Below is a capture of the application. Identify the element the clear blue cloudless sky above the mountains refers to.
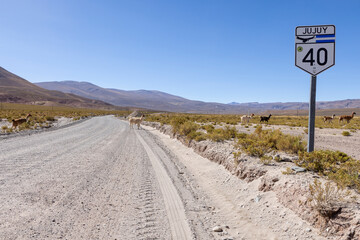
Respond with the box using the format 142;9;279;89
0;0;360;103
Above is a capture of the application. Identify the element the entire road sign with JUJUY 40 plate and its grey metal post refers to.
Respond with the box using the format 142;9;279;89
295;25;335;152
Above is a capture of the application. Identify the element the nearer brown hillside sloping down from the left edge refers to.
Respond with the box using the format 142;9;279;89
0;67;114;109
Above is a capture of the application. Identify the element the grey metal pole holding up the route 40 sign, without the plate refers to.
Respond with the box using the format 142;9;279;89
308;76;316;152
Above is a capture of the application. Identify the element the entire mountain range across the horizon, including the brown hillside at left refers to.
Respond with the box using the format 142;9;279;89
0;67;360;114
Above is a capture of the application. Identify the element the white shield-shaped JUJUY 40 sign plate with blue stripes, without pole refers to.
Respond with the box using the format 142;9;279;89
295;25;335;76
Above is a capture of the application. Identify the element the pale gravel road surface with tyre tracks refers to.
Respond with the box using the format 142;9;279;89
0;116;200;240
